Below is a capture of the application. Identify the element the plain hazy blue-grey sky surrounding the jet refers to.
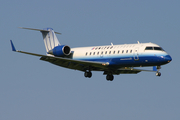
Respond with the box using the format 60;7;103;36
0;0;180;120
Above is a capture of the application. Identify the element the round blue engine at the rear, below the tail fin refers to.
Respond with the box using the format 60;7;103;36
48;45;71;57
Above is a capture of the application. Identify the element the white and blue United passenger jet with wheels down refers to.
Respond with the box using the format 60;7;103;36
10;27;172;81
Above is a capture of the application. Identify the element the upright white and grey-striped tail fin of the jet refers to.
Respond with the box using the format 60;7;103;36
41;28;60;52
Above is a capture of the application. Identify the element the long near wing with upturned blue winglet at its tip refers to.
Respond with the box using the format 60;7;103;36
10;40;108;71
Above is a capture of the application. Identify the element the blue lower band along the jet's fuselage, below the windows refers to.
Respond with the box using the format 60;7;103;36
74;53;170;67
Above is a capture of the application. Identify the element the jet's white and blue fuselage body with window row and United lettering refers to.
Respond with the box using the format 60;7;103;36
72;43;170;66
